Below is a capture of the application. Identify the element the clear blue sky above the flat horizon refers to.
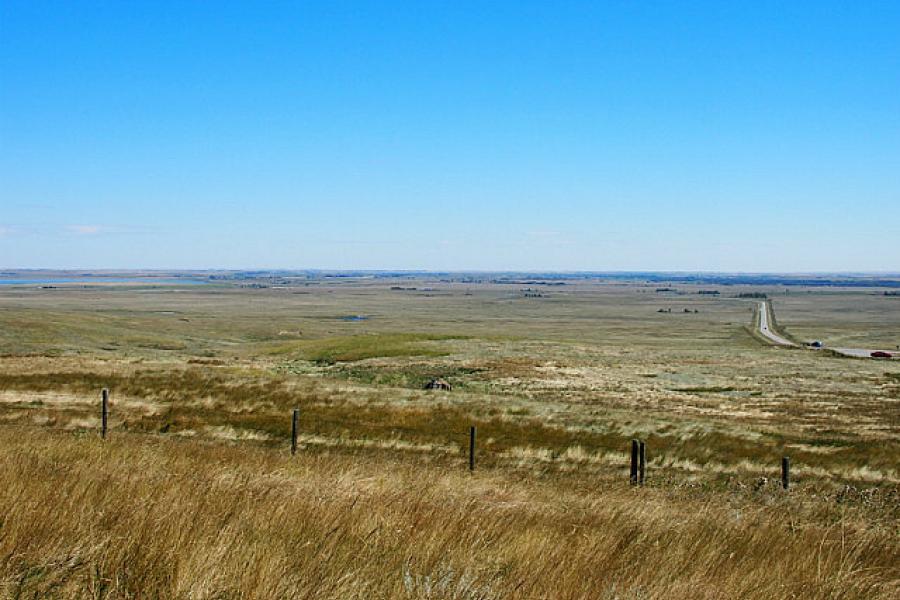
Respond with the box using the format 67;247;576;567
0;0;900;271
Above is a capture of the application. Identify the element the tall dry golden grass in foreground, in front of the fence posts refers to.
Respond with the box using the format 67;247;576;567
0;428;900;599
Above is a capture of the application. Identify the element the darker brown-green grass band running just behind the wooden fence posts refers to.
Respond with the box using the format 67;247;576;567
0;366;900;483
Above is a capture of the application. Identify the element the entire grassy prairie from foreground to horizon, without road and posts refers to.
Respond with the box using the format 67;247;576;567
0;279;900;598
